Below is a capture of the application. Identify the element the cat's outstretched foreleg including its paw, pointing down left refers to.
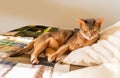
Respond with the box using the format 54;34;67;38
48;45;69;62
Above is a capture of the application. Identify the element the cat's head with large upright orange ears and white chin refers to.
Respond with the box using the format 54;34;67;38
78;18;103;40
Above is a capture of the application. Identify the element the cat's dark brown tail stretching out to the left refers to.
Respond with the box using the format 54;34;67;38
10;40;34;56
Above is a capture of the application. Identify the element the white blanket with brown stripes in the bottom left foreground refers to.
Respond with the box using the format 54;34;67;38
0;59;70;78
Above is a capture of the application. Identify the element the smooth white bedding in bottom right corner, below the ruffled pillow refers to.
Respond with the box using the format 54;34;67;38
58;63;120;78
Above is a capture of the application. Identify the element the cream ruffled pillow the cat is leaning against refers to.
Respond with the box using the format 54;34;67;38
63;23;120;66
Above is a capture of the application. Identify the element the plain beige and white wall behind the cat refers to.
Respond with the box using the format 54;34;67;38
0;0;120;32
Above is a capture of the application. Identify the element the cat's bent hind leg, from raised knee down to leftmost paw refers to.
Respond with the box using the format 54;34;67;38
31;37;59;64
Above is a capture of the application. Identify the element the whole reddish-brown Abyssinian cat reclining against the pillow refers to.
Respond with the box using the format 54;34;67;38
13;18;103;64
